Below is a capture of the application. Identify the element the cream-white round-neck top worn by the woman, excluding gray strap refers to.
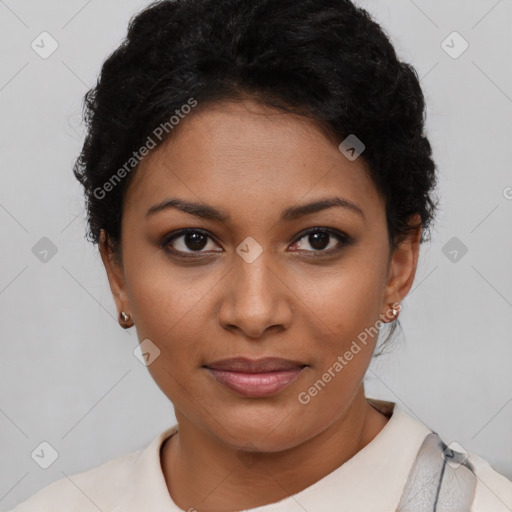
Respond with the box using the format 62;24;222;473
11;398;512;512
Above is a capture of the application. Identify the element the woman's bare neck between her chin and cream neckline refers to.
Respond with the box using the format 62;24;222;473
161;385;388;512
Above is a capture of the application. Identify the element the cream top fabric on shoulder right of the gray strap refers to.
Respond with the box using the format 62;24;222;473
468;453;512;512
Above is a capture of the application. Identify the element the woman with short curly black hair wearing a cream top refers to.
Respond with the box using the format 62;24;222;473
9;0;512;512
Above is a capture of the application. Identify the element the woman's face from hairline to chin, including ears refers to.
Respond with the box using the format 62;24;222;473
102;100;416;451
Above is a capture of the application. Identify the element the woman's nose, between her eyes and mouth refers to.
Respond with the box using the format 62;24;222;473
218;251;294;340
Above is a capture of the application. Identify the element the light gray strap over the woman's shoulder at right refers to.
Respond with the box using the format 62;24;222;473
396;432;476;512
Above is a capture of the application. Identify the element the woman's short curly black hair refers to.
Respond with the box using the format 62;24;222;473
73;0;437;354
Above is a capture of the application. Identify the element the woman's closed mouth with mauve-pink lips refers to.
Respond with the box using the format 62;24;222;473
204;357;308;398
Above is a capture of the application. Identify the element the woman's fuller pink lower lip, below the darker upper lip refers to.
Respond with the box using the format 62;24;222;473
207;368;304;398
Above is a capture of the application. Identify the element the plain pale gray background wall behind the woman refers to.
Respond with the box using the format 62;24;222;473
0;0;512;511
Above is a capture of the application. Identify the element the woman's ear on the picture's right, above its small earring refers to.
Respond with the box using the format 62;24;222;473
381;214;422;315
